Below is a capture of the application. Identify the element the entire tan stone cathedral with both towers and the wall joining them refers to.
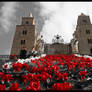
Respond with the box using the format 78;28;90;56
11;13;92;55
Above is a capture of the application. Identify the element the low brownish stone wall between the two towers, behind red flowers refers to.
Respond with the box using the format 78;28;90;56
44;43;71;54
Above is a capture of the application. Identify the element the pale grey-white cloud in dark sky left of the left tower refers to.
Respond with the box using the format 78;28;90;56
0;2;19;32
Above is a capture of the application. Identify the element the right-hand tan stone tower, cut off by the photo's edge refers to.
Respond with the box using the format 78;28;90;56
71;13;92;55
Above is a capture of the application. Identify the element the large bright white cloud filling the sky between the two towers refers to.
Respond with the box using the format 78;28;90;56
40;2;92;43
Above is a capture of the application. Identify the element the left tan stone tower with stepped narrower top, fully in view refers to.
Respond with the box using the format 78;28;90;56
11;13;37;55
